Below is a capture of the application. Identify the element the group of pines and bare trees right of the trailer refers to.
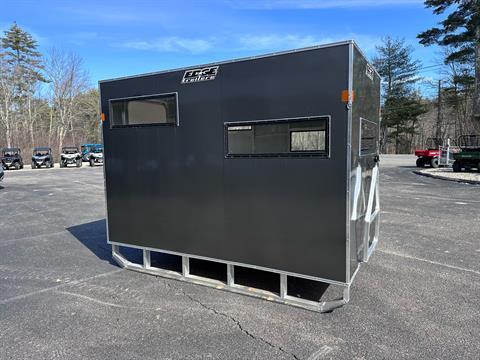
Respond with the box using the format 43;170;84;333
373;0;480;153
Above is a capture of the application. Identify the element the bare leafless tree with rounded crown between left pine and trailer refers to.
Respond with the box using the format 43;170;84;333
45;49;89;151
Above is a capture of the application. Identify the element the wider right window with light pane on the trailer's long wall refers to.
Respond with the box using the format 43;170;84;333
225;116;329;157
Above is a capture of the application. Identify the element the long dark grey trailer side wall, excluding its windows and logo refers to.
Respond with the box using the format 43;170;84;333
100;44;349;282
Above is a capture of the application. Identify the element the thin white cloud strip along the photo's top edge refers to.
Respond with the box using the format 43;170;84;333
228;0;423;10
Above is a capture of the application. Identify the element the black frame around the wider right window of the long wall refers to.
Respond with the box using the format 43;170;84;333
223;115;332;159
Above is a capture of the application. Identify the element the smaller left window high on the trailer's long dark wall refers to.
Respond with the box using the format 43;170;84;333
111;94;178;127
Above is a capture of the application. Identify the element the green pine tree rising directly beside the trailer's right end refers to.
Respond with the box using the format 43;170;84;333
373;37;426;153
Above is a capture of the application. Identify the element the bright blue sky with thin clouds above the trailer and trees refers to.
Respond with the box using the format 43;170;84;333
0;0;440;94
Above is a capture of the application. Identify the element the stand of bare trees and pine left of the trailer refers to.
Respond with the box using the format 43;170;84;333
0;23;101;158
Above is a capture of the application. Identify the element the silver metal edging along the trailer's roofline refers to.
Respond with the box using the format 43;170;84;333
98;40;380;84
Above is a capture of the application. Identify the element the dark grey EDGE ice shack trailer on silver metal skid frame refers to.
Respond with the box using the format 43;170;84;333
99;41;380;311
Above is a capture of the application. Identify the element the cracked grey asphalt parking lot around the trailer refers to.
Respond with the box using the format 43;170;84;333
0;156;480;360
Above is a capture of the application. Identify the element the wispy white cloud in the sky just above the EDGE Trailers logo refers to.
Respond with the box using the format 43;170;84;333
120;36;213;53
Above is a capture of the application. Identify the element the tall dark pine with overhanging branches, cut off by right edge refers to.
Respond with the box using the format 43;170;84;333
418;0;480;122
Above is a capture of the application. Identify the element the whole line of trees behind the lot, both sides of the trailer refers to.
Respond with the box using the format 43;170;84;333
0;0;480;153
